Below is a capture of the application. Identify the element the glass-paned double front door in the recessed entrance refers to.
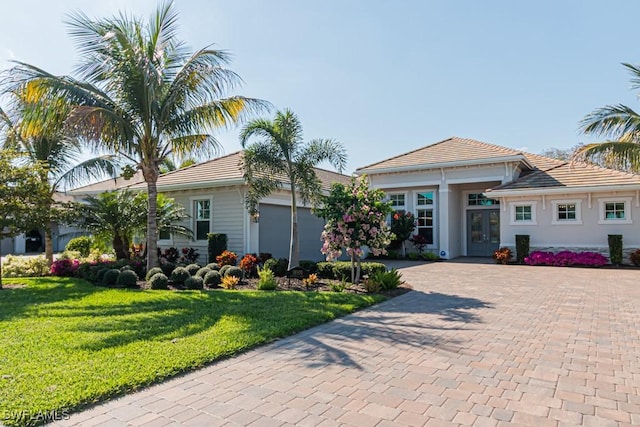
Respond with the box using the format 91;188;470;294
467;209;500;256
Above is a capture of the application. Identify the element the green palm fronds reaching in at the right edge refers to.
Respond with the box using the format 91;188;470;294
574;64;640;173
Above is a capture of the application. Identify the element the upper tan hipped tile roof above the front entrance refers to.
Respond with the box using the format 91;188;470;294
356;136;562;173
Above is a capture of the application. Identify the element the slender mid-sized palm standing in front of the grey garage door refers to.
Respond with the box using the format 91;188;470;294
240;110;347;269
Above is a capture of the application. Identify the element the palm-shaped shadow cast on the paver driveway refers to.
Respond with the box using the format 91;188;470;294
280;291;493;369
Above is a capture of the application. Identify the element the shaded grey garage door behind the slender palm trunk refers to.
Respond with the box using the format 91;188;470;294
259;203;324;261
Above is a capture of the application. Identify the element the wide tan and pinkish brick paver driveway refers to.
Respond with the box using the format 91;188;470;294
60;262;640;426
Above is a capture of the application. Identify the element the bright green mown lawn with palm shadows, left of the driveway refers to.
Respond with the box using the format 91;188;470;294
0;277;383;425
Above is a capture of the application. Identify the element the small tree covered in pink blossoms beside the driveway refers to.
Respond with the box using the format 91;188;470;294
315;176;395;283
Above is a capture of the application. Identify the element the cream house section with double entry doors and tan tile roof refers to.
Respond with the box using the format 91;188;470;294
356;137;640;259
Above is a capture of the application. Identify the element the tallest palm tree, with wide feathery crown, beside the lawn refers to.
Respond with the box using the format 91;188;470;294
5;3;267;268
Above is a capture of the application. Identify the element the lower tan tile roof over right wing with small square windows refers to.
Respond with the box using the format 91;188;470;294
489;162;640;192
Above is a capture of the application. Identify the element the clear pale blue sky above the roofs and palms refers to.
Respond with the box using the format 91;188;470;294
0;0;640;172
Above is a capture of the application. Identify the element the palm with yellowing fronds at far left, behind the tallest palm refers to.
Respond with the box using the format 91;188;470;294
0;90;116;263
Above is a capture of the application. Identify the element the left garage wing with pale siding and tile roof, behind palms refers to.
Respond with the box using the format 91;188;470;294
72;151;350;262
